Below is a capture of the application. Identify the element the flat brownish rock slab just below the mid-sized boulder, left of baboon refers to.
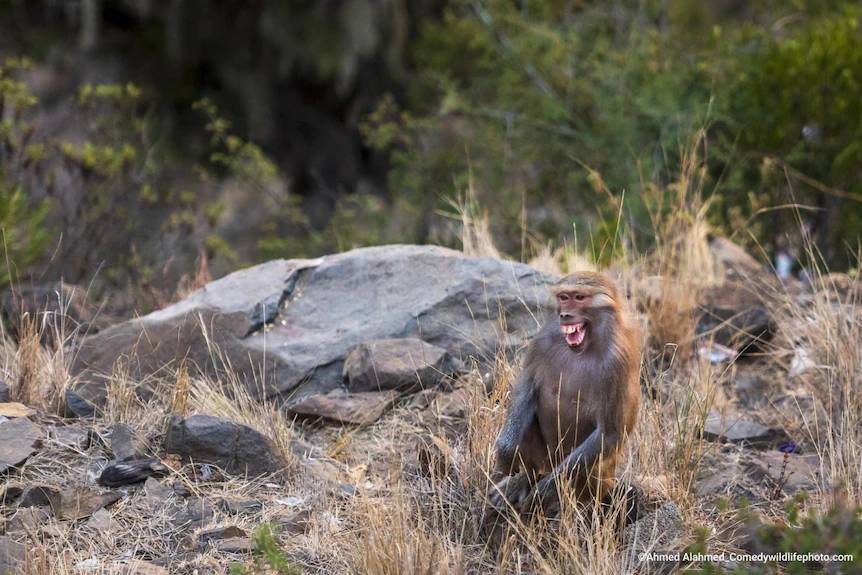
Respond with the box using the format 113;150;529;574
288;390;400;425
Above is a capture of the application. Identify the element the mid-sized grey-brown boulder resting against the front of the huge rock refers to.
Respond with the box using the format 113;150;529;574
344;337;455;392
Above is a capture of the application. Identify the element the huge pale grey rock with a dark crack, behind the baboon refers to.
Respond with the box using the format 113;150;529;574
72;245;554;403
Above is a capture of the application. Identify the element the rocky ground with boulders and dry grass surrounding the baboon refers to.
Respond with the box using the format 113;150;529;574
0;244;862;574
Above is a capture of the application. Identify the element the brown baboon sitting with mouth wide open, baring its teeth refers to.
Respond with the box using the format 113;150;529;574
490;272;640;511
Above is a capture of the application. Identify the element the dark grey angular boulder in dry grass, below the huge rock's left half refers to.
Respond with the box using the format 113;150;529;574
165;415;285;477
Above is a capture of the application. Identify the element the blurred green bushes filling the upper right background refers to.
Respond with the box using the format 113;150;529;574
364;0;862;266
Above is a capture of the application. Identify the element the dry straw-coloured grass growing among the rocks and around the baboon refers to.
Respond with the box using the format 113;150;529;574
0;137;862;575
